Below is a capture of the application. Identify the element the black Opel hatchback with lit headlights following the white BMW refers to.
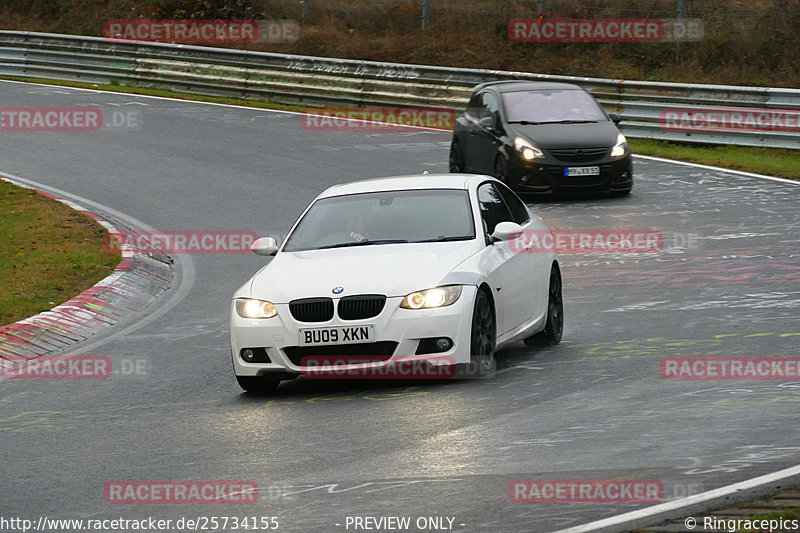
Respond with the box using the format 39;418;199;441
450;81;633;194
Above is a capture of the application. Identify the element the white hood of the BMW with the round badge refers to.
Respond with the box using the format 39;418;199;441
243;239;478;303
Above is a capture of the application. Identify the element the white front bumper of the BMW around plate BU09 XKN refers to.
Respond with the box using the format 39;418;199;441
230;285;477;378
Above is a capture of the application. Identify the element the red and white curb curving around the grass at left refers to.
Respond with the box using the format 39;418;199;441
0;175;173;365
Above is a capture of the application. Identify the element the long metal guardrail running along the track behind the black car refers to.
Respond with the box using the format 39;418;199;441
0;31;800;149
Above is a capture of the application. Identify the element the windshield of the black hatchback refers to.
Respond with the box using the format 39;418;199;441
502;90;607;124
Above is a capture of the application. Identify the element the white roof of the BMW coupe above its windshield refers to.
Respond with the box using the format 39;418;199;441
318;174;494;198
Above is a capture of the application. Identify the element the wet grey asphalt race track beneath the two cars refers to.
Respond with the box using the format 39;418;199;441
0;82;800;532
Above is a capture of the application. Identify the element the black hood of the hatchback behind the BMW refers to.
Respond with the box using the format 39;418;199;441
510;121;619;149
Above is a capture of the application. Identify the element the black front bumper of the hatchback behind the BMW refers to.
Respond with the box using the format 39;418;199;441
509;155;633;194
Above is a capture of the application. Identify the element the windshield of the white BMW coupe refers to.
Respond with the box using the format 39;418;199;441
283;189;475;252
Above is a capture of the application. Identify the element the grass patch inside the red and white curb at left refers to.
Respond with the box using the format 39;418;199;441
0;180;120;325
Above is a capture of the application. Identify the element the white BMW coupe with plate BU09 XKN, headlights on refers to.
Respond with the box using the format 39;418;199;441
230;174;564;392
